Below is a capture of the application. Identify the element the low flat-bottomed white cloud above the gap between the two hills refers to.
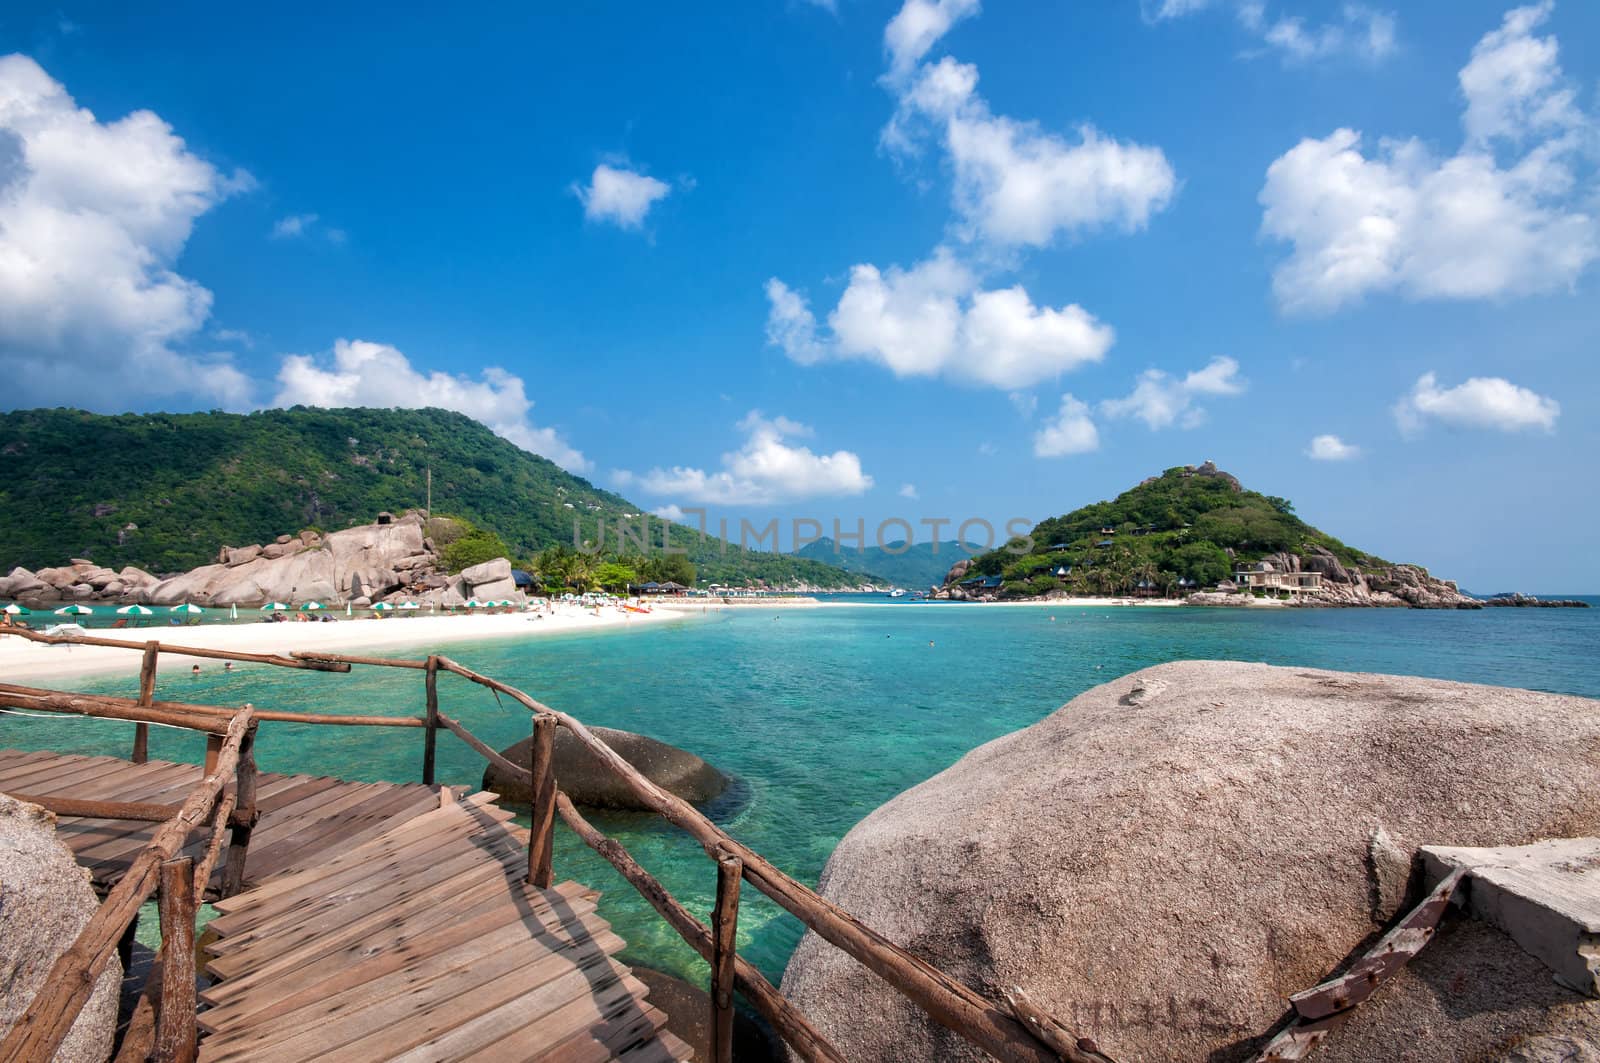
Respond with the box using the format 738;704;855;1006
624;410;872;506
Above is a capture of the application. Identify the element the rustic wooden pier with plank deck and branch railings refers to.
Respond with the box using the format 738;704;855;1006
0;631;1107;1063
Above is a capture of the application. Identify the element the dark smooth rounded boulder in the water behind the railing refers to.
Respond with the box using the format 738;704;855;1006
483;727;728;808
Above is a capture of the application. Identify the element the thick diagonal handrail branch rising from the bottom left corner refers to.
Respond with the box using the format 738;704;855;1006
0;706;254;1063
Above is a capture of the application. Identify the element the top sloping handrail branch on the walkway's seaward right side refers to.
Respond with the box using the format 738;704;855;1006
438;656;1081;1063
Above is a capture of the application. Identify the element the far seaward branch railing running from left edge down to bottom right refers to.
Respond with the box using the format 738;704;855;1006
0;632;1109;1063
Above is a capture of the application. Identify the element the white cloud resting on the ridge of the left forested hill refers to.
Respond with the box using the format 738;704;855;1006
272;339;590;472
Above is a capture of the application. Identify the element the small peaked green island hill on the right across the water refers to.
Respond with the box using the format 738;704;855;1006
966;463;1389;596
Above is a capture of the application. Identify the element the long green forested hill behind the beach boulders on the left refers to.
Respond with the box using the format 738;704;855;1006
0;407;859;588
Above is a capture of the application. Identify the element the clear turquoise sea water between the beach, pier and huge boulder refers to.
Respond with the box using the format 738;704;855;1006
0;599;1600;981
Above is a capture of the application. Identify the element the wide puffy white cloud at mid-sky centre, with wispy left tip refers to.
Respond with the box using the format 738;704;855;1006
766;248;1115;389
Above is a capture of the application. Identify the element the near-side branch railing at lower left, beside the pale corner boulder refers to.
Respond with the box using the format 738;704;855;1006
0;688;258;1063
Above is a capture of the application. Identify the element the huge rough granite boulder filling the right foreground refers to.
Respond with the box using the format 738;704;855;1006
782;661;1600;1060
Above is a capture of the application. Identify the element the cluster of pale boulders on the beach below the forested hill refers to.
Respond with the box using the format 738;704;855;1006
0;511;522;607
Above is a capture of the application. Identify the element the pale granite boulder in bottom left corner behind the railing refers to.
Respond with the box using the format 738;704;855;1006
0;794;122;1063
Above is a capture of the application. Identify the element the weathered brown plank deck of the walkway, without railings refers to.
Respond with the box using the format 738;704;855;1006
0;749;693;1063
